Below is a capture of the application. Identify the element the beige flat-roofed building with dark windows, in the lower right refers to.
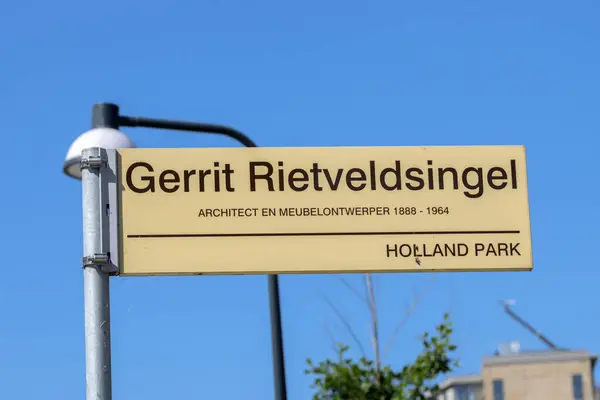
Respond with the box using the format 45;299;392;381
436;350;600;400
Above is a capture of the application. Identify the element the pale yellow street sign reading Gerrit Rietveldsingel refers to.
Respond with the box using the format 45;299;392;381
112;146;533;275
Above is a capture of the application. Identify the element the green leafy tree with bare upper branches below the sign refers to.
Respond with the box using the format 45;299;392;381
305;274;458;400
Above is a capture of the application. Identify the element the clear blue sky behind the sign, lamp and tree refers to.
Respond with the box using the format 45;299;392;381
0;0;600;400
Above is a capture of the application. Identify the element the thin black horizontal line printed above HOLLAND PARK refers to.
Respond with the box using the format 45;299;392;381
127;230;521;239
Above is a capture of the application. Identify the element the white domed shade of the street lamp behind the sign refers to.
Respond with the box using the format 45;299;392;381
63;128;135;179
